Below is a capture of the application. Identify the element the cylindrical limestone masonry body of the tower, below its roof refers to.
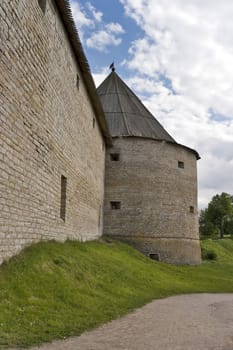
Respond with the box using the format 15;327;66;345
104;137;200;264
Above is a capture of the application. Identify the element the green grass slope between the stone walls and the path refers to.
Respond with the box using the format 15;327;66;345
0;239;233;349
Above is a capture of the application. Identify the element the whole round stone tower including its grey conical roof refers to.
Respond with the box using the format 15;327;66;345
97;69;201;265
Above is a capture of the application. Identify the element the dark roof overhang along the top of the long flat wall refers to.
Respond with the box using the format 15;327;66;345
55;0;112;145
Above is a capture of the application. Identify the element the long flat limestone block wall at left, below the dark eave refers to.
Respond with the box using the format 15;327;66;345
0;0;105;261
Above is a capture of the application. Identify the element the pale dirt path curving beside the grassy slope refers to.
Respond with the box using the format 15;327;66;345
22;294;233;350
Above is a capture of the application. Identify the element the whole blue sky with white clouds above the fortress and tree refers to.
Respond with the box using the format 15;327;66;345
70;0;233;208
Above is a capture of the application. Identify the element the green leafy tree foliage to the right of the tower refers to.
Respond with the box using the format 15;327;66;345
199;192;233;237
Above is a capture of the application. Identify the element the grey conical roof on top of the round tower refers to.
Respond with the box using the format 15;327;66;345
97;70;176;143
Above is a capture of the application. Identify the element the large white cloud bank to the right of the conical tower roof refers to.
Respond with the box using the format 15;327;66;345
120;0;233;206
